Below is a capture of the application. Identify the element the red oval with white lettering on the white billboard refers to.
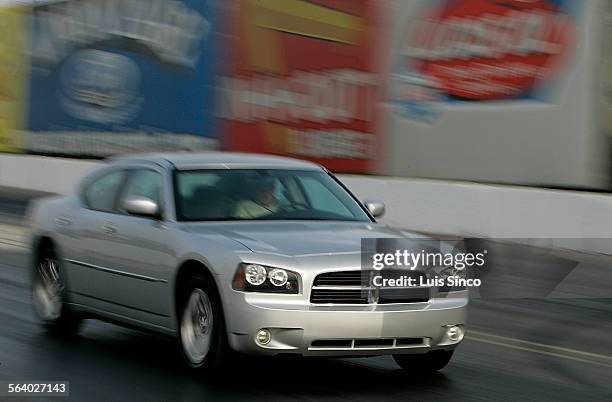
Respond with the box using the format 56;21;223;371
402;0;575;100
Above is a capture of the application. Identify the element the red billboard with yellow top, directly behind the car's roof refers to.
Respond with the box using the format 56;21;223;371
216;0;381;172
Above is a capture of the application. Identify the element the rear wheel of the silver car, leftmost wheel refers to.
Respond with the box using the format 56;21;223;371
32;245;82;335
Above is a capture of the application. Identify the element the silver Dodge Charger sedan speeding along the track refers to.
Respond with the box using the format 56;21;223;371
28;153;468;371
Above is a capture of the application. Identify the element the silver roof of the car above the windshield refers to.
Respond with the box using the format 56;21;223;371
110;152;321;170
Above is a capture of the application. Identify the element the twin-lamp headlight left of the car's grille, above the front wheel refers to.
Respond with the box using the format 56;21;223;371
232;264;300;294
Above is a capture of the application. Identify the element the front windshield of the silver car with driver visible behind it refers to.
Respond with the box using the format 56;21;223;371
175;169;370;222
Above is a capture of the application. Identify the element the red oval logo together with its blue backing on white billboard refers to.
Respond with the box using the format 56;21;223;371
391;0;576;122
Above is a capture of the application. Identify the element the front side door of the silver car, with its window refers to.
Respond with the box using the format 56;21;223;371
97;165;174;325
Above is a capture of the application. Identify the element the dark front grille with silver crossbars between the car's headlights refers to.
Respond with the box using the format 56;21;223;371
310;270;430;304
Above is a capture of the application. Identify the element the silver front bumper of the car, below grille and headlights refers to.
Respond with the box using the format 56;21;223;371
226;291;468;356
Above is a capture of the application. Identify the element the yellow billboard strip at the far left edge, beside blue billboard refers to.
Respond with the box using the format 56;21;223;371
0;7;29;152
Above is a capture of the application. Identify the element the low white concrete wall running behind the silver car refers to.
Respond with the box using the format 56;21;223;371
0;154;612;254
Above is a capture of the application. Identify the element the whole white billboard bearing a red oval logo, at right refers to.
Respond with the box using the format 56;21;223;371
383;0;610;189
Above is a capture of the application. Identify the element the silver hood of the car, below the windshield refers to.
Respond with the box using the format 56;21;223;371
179;221;423;256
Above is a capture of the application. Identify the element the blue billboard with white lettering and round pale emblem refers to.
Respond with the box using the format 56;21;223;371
26;0;223;156
